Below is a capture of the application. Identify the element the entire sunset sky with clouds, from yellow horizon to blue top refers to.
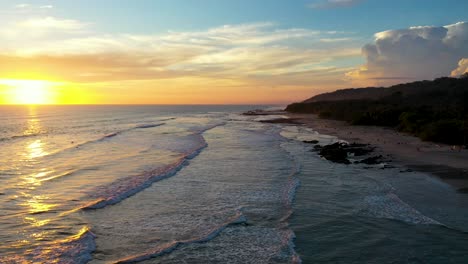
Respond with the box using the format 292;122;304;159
0;0;468;104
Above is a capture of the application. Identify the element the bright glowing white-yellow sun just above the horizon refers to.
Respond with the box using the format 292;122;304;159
0;79;54;105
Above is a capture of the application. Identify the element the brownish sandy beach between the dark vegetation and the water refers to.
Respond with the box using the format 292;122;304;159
287;114;468;192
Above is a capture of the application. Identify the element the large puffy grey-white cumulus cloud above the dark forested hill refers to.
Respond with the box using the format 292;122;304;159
347;22;468;85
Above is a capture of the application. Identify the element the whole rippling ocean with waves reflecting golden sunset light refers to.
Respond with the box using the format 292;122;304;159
0;106;468;263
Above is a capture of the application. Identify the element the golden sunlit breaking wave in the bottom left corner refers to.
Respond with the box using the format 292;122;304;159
0;227;96;264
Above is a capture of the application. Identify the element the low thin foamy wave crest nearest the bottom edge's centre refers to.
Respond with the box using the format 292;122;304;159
114;210;247;264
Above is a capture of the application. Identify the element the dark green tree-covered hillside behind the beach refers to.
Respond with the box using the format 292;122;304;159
286;77;468;145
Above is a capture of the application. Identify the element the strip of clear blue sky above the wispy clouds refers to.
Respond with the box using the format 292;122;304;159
29;0;468;37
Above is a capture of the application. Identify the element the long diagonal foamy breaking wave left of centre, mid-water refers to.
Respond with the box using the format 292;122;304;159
82;123;225;210
